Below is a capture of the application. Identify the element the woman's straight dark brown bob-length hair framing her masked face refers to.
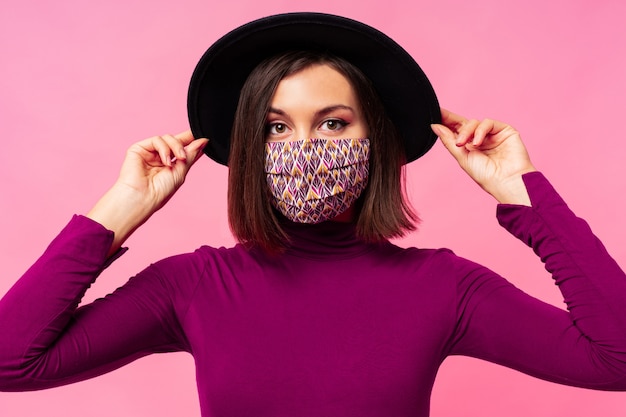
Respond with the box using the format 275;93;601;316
228;51;419;252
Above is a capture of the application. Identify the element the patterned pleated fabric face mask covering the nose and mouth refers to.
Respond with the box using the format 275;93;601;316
265;139;369;223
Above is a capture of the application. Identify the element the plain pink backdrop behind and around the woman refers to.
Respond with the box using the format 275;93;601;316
0;0;626;417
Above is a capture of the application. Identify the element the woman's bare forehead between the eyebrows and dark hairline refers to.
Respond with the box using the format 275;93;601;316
272;64;357;106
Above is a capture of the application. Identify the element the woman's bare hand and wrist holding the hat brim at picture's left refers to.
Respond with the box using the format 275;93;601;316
87;131;208;253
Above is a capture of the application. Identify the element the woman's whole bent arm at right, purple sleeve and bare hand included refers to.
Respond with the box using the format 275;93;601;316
433;110;626;384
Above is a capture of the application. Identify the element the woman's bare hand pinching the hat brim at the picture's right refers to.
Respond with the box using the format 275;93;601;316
432;109;536;206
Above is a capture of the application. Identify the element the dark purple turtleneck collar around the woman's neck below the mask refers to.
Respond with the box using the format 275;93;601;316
282;220;380;259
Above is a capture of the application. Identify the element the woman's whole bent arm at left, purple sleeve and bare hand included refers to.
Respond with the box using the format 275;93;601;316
0;132;206;390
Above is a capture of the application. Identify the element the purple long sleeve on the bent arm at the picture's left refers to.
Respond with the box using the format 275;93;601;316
0;216;188;391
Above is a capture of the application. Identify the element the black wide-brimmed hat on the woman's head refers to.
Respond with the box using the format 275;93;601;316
187;12;441;165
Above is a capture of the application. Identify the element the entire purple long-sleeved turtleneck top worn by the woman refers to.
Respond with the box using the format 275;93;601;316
0;173;626;417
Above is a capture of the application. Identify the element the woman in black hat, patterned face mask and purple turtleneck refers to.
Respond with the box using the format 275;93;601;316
0;13;626;416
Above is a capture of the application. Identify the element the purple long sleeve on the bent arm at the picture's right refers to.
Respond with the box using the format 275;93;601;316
451;173;626;390
